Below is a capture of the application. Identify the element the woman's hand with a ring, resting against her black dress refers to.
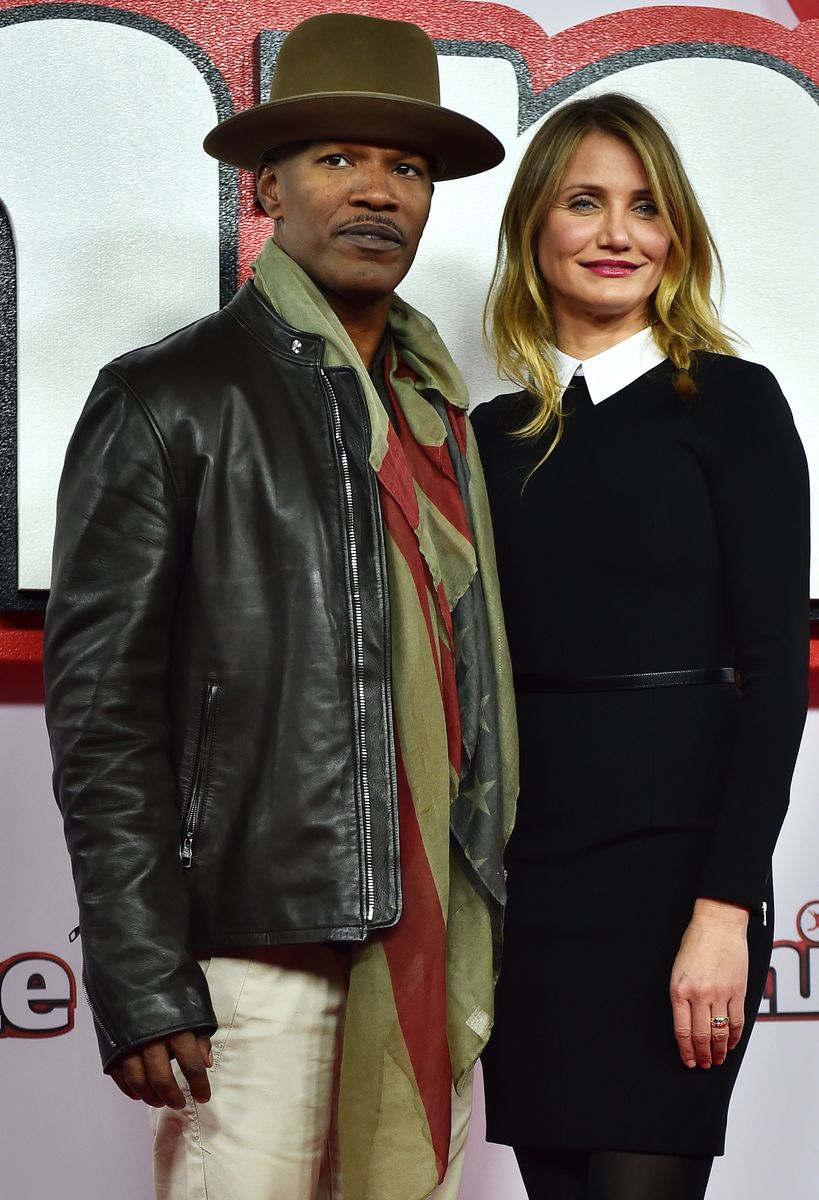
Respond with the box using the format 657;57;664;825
670;900;748;1069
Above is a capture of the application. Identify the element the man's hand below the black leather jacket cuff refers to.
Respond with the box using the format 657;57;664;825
110;1030;214;1109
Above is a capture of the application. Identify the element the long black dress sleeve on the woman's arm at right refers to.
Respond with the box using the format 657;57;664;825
699;359;809;910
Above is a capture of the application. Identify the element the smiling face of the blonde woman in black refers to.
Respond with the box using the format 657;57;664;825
536;131;670;344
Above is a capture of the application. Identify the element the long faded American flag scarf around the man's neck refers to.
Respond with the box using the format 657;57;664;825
255;241;518;1200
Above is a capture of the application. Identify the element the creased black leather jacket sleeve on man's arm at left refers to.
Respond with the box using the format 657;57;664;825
43;370;215;1067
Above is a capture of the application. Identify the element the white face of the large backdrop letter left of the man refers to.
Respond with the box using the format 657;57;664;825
0;20;219;588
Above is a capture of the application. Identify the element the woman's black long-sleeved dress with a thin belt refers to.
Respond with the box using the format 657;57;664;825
472;354;808;1156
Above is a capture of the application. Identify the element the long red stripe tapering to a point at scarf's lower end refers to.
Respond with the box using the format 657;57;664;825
382;739;453;1182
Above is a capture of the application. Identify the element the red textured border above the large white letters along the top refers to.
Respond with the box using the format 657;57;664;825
0;0;819;284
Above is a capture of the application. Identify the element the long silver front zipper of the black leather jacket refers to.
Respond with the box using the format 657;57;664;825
322;371;375;922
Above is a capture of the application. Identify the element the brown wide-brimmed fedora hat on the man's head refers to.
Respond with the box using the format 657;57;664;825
204;12;504;179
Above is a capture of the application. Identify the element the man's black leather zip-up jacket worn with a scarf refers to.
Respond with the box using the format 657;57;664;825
44;284;401;1064
